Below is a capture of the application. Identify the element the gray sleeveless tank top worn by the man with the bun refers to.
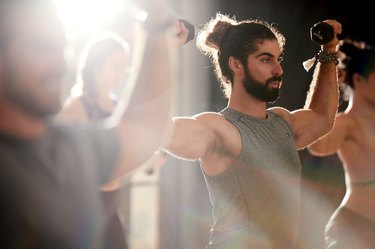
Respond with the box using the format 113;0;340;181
202;108;301;249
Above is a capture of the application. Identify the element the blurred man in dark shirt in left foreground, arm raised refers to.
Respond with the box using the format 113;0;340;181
0;0;182;249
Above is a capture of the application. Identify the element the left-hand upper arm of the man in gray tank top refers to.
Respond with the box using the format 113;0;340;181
165;117;216;160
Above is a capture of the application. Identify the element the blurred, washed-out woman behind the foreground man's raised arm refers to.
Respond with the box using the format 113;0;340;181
57;22;189;249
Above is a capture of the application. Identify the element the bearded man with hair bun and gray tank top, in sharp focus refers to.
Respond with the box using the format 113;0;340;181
165;14;341;249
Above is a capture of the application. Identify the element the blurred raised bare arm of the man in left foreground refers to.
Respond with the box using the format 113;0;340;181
108;3;177;181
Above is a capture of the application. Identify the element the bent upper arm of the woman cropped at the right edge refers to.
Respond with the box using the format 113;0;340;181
308;115;349;156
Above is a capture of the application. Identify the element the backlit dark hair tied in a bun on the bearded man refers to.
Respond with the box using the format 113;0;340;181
197;13;285;97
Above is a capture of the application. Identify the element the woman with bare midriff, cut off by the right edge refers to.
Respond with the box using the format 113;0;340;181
309;39;375;249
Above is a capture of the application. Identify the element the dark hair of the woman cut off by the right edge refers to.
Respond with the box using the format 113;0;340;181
340;40;375;89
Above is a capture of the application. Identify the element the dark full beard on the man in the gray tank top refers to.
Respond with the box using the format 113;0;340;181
242;67;282;103
